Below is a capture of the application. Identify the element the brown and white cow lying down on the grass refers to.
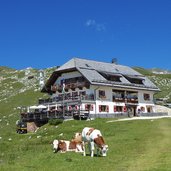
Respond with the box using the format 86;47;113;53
53;140;83;153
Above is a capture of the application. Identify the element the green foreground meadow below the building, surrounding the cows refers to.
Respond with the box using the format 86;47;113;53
0;118;171;171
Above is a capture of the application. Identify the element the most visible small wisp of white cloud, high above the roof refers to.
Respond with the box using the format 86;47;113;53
86;19;106;31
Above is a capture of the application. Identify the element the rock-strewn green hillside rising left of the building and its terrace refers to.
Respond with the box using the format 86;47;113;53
0;67;56;131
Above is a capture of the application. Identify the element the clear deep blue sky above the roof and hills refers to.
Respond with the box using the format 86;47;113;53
0;0;171;69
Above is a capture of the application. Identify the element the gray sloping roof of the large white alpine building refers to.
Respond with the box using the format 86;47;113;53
56;58;159;90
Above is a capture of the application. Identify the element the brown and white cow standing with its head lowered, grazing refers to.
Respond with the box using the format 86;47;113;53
74;127;108;157
